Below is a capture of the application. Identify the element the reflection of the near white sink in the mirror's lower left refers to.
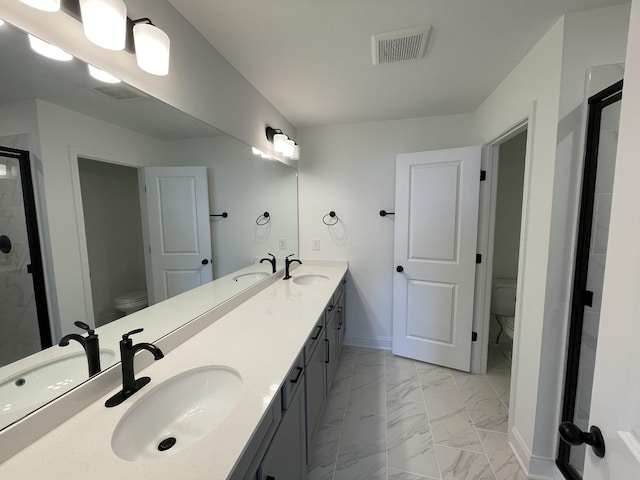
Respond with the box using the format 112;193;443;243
0;349;115;425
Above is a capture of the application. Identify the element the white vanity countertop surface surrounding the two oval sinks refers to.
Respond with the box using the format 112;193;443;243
0;261;347;480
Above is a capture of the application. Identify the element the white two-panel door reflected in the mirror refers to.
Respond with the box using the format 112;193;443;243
142;167;212;303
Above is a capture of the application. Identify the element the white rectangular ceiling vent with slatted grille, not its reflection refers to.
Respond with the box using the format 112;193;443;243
371;25;431;65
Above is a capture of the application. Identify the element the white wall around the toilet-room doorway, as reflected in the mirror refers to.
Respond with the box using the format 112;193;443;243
36;100;164;340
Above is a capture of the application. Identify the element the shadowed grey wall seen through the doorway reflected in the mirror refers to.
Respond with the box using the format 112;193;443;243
78;158;147;326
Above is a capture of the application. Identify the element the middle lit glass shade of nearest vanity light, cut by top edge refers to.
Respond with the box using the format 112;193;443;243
80;0;127;50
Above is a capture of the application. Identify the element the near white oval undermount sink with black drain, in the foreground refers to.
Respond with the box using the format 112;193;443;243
111;365;243;462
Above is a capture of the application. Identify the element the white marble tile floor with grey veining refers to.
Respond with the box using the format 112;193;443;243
307;345;526;480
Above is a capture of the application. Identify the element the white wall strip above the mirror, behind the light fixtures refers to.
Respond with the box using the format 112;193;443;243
0;0;295;151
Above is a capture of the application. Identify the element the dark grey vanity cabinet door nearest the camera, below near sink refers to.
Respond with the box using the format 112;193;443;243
258;379;307;480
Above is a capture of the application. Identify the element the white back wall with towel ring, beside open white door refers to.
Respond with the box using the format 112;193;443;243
298;115;477;348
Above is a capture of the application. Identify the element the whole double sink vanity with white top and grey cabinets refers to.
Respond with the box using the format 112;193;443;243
0;261;347;480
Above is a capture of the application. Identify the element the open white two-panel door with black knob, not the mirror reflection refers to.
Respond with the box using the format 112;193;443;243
393;147;480;372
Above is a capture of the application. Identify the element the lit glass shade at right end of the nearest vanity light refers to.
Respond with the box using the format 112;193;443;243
133;23;170;75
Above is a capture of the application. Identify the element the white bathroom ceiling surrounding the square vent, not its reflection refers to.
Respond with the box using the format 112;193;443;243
169;0;628;127
